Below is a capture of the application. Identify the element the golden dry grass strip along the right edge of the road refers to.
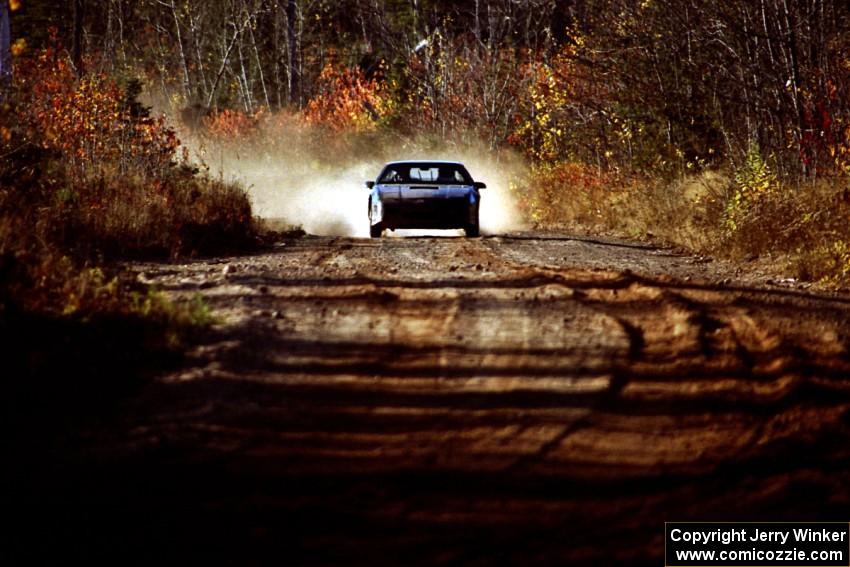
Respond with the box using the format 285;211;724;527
515;163;850;288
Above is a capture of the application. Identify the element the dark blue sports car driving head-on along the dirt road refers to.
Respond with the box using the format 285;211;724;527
366;161;487;238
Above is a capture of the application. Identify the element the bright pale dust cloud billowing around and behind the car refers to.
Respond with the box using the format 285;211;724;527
183;128;525;237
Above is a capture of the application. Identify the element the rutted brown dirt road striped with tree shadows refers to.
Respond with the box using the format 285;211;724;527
18;233;850;565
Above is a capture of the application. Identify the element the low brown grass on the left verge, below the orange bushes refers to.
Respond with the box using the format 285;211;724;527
0;146;235;398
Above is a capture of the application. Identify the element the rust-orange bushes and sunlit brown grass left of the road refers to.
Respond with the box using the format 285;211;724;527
0;42;253;338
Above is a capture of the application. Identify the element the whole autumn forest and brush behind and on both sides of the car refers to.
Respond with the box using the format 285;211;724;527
0;0;850;368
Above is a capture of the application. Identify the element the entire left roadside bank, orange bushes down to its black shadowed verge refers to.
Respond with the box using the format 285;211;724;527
0;48;259;406
